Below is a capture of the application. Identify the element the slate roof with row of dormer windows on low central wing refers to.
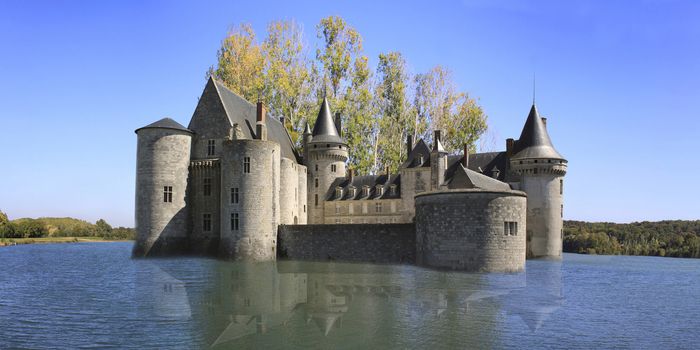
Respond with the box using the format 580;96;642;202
326;174;401;201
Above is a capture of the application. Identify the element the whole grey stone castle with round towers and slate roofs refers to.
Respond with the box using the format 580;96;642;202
133;78;567;271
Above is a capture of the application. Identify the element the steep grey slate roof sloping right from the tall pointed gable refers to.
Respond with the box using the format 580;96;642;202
210;78;298;162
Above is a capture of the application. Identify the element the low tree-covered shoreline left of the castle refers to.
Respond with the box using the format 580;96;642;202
0;211;134;239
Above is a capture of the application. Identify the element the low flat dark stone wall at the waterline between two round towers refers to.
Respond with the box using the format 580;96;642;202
277;224;416;264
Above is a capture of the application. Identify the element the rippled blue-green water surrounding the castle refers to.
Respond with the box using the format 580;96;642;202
0;243;700;349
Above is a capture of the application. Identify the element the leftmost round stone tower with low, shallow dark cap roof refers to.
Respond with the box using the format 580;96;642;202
133;118;192;257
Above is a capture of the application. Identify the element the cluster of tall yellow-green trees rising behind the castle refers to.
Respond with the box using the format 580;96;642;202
207;16;487;174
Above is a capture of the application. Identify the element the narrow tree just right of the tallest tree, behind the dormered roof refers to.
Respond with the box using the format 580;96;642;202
375;52;411;171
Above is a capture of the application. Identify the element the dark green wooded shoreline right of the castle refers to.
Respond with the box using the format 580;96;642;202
564;220;700;258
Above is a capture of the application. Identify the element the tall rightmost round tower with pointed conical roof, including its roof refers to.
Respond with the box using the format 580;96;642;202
510;104;567;259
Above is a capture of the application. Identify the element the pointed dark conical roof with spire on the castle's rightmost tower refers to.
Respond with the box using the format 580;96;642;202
513;103;564;159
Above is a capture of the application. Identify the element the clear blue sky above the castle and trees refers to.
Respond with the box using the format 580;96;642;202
0;0;700;226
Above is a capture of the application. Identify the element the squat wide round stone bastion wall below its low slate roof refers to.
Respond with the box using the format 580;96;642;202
416;189;526;272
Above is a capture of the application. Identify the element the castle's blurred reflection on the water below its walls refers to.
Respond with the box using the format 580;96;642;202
137;260;564;348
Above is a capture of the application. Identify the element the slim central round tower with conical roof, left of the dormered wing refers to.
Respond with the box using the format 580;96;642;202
304;97;348;224
